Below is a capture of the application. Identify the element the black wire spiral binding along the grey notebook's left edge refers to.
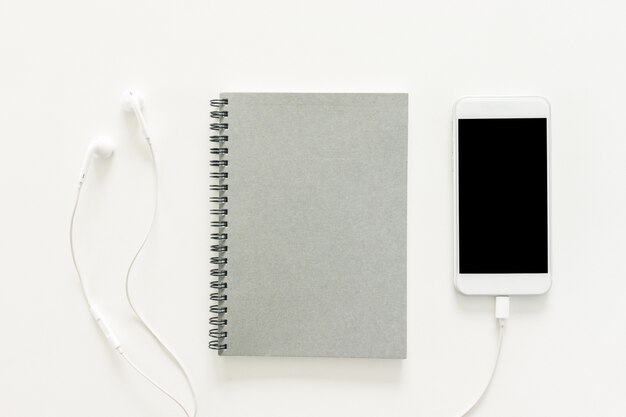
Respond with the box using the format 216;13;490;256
209;98;228;350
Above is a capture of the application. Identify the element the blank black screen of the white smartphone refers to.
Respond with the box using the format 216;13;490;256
458;118;548;274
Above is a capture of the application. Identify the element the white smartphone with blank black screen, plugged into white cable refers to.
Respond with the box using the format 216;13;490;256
453;97;552;295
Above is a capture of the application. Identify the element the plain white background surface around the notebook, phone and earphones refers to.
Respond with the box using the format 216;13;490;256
0;0;626;417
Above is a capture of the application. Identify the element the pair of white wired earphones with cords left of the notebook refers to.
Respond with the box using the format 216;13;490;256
69;90;198;417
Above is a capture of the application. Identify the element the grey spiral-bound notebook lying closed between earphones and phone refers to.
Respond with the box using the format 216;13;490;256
209;93;408;358
